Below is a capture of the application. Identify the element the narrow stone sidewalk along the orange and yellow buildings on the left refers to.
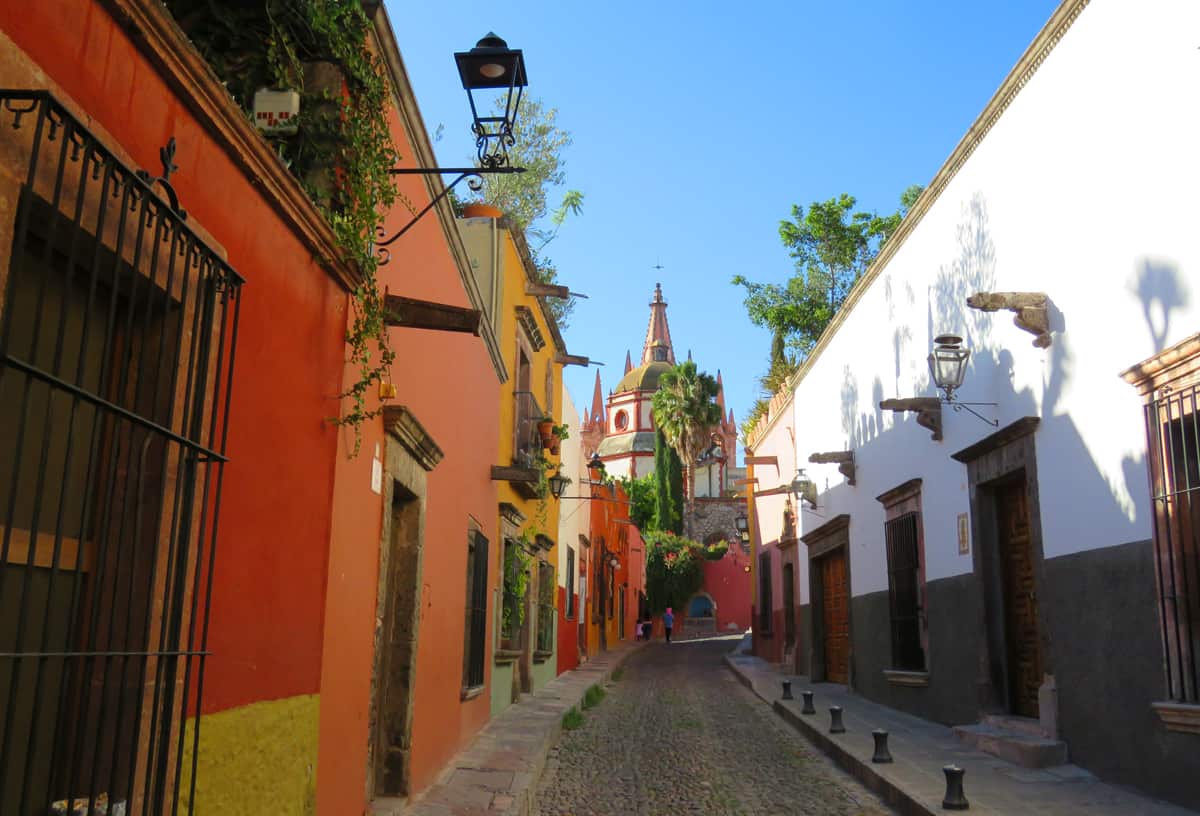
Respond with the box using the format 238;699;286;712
386;642;644;816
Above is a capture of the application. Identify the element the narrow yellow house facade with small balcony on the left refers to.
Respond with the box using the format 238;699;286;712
460;208;566;715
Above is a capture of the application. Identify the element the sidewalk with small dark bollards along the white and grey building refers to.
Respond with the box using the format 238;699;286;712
726;647;1195;816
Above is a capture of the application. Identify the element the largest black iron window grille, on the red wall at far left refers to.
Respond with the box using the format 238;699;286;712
0;90;241;816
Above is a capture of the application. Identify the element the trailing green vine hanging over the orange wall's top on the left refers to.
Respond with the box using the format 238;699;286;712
166;0;415;456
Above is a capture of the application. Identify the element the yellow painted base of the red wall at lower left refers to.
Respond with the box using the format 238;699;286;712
180;695;319;816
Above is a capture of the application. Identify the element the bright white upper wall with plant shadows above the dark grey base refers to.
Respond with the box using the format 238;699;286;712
787;0;1200;602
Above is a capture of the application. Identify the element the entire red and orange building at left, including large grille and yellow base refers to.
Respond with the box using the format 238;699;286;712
0;0;506;816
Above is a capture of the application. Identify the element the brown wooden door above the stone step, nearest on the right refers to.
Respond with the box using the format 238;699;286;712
996;479;1042;718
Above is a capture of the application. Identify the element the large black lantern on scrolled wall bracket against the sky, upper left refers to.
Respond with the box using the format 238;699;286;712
374;31;528;261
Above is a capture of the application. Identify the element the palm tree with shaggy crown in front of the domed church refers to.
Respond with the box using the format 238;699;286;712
652;360;721;515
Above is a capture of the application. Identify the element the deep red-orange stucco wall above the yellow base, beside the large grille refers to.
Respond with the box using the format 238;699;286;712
0;0;346;713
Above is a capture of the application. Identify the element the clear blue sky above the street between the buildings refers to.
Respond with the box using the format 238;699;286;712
386;0;1057;458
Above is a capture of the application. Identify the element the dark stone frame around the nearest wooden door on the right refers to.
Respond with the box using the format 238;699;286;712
952;416;1054;719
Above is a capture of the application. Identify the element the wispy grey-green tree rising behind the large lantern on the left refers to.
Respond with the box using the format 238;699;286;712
475;96;583;329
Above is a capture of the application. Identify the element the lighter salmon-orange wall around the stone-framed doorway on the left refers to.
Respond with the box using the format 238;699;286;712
317;75;499;816
